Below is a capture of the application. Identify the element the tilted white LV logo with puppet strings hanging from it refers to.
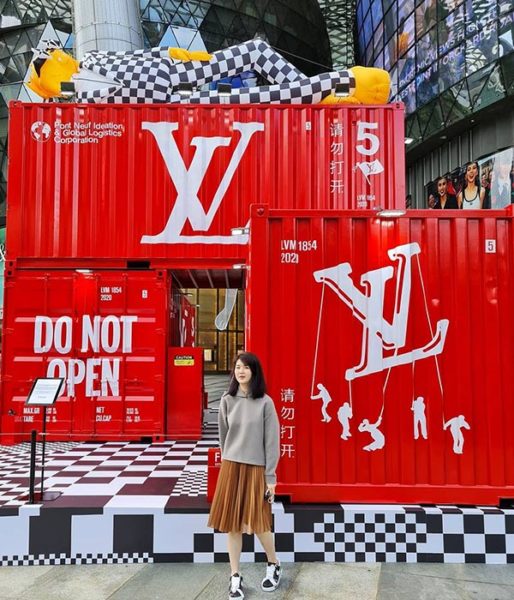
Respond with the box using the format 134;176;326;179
314;243;449;381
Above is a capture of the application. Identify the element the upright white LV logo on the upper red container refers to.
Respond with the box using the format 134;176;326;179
141;121;264;244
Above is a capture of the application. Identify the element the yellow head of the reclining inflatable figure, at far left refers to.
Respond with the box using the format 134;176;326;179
27;49;79;98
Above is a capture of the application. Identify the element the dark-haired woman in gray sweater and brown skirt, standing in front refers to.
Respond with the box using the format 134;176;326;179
208;352;282;599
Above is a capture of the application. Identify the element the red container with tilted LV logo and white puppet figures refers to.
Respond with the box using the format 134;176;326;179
247;207;514;504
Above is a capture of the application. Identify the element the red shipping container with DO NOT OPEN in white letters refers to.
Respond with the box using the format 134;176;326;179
1;266;168;442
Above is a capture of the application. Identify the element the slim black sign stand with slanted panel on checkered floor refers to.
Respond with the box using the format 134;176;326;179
25;377;64;504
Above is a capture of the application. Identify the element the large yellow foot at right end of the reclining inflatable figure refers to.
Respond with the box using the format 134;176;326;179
320;67;391;104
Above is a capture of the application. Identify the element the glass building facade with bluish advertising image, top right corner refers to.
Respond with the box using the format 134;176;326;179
357;0;514;145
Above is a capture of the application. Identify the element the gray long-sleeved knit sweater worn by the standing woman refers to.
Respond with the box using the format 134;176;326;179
218;390;280;483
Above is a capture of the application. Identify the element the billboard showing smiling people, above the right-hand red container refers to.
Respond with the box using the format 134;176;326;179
425;147;514;210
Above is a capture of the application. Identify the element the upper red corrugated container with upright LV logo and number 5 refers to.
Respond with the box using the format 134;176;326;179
7;102;405;264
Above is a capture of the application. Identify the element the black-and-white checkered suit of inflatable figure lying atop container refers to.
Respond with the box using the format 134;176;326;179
77;40;355;104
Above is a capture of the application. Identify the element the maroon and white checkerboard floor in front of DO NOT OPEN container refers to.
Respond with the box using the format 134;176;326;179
0;423;218;509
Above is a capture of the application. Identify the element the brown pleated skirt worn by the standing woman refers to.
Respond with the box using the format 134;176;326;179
207;460;271;533
